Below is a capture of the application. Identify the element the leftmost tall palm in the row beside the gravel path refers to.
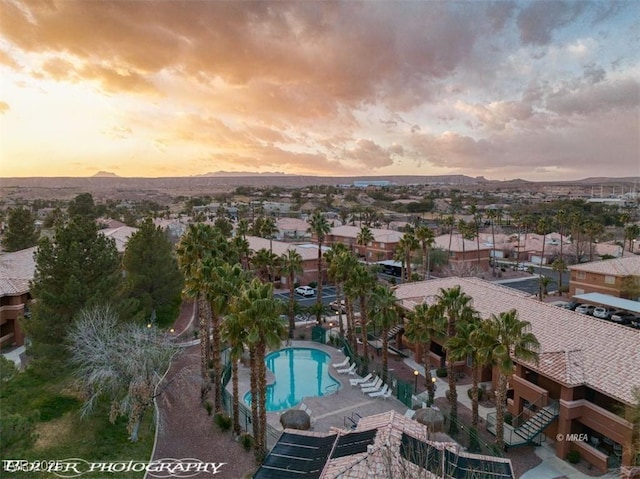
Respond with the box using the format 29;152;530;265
176;223;216;402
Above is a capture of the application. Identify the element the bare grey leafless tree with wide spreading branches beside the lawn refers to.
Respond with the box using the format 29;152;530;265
69;306;177;442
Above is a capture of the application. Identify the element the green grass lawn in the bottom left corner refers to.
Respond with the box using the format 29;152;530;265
0;370;155;479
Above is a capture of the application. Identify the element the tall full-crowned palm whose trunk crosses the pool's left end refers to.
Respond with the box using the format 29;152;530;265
232;278;284;461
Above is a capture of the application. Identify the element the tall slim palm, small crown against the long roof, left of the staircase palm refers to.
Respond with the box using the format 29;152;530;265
433;285;477;434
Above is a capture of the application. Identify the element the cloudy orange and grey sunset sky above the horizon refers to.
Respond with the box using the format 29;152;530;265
0;0;640;181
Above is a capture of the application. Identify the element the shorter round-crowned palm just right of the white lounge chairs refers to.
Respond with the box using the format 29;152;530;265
404;303;445;406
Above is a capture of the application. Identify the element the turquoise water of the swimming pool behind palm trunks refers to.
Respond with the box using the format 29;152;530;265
244;348;340;411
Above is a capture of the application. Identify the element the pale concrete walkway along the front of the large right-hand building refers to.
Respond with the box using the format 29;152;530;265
404;358;619;479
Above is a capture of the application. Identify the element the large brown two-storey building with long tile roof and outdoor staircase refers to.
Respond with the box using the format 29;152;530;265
395;278;640;472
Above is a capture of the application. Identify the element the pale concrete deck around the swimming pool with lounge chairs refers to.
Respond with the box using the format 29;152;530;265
235;341;407;432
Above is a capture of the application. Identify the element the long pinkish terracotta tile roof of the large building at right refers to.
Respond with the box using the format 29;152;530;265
395;277;640;405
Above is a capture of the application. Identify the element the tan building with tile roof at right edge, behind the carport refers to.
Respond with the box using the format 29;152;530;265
569;255;640;299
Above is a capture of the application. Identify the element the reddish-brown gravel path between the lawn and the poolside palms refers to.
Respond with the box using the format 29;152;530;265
153;303;256;479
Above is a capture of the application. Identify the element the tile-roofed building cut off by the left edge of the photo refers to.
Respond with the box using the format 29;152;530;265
0;247;36;348
